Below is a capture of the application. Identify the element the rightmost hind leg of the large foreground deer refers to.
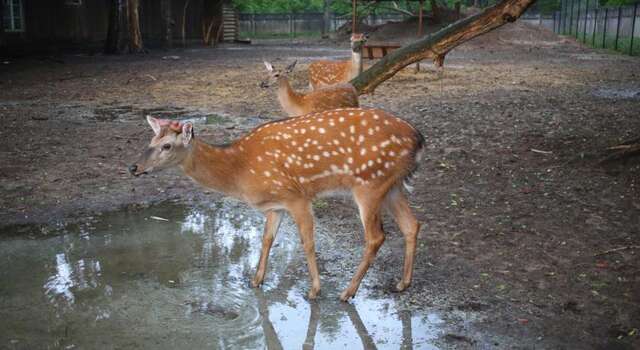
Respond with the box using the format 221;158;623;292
385;186;420;292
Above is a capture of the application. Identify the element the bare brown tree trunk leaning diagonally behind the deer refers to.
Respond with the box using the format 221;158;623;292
351;0;535;95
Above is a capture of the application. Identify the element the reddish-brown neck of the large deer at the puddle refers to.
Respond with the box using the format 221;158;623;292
181;139;242;197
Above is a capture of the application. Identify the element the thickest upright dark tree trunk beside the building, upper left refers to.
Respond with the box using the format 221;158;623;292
104;0;144;54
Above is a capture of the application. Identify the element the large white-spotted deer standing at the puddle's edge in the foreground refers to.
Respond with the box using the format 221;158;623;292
129;108;424;301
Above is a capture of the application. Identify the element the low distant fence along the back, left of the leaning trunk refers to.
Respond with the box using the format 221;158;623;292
239;13;406;36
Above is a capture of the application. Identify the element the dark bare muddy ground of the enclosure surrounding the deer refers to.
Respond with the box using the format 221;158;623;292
0;24;640;349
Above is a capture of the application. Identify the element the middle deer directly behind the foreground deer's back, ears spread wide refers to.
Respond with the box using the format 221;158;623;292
260;61;359;117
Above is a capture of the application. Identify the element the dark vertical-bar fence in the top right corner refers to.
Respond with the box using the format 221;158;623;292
553;0;640;55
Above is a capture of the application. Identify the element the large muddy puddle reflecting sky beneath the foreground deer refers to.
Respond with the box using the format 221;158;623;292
0;201;445;349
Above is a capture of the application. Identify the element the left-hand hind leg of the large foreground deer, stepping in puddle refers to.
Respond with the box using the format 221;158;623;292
340;188;384;301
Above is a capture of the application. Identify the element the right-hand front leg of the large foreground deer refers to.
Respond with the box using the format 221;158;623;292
287;201;320;299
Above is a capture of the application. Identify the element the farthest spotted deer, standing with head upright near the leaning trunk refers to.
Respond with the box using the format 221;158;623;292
309;33;367;90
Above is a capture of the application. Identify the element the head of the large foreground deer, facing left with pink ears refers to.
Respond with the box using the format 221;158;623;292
129;116;193;176
